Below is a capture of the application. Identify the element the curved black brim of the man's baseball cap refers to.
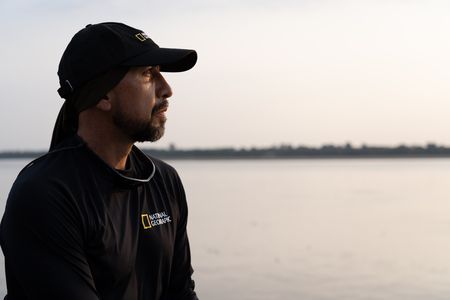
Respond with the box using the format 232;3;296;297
121;48;197;72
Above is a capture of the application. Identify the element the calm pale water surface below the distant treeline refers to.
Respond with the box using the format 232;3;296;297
0;159;450;300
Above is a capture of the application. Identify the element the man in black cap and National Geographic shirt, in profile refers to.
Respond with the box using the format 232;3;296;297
0;23;197;300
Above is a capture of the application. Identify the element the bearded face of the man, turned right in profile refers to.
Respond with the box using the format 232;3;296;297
108;67;172;142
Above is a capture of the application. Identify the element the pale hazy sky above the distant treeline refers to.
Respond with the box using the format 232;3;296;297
0;0;450;151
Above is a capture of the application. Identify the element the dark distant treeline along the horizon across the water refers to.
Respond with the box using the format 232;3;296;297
0;144;450;159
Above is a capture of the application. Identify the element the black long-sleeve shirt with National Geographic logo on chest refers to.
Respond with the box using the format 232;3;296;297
0;136;197;300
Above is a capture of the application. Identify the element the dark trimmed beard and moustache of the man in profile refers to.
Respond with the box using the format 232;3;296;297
112;100;169;142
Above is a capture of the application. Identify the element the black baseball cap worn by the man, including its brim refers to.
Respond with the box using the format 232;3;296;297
58;22;197;99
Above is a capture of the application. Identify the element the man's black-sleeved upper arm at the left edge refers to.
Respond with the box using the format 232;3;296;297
0;179;98;300
